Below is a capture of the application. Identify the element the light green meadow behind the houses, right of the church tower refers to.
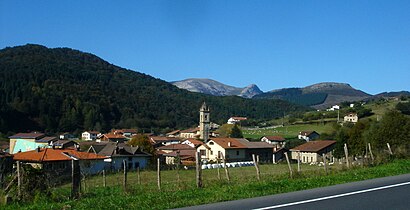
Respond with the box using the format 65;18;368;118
242;123;333;139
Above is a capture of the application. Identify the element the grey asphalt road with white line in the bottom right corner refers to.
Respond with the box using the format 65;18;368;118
176;174;410;210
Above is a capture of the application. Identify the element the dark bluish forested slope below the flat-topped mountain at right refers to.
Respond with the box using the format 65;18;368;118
253;88;327;106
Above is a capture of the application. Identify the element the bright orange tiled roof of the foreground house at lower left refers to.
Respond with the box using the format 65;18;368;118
13;148;107;162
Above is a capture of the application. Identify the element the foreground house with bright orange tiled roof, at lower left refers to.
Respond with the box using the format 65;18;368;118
13;148;107;176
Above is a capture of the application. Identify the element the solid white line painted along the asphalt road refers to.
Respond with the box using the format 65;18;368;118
255;182;410;210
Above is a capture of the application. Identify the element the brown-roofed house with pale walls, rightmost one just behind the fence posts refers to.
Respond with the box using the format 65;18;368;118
290;140;336;163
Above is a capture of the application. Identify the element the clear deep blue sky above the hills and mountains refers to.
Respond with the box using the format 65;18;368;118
0;0;410;94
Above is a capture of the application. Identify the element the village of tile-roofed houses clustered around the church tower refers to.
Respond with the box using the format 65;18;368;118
0;103;357;180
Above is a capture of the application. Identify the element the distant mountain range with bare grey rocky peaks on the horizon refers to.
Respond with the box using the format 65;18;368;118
172;79;398;109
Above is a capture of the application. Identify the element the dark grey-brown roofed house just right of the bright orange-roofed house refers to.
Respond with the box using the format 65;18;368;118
88;142;152;171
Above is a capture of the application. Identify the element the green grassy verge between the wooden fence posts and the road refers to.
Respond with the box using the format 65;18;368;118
0;160;410;209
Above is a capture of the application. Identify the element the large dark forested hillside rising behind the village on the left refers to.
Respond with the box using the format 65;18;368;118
0;44;307;133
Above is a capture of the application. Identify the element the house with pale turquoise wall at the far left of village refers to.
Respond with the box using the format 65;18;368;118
9;132;48;154
